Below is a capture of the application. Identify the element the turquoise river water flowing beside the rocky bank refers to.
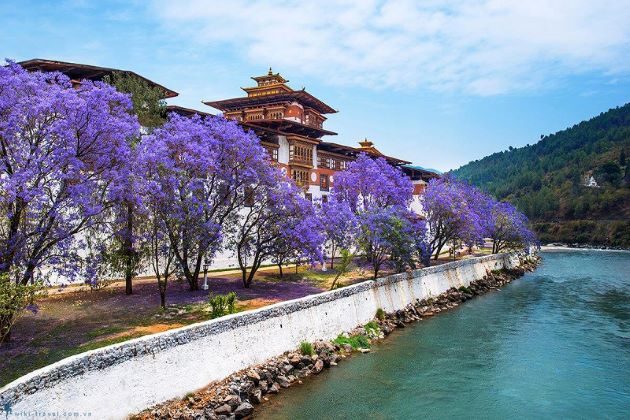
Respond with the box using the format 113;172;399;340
259;251;630;419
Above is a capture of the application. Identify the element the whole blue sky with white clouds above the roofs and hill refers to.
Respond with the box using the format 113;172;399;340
0;0;630;171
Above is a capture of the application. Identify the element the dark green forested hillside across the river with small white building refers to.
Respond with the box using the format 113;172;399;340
452;103;630;247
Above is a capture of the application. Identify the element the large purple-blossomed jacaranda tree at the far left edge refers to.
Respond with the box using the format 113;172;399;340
0;63;139;342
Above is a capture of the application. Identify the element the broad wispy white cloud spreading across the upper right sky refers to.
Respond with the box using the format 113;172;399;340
153;0;630;95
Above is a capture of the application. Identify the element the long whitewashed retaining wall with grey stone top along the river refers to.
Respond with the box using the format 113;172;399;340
0;254;520;419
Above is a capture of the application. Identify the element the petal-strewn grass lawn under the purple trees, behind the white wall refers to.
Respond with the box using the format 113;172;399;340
0;266;376;386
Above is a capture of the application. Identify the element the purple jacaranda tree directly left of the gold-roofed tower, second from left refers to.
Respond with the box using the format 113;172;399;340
138;114;269;290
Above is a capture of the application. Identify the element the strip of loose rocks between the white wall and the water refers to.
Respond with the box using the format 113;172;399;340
132;258;539;420
